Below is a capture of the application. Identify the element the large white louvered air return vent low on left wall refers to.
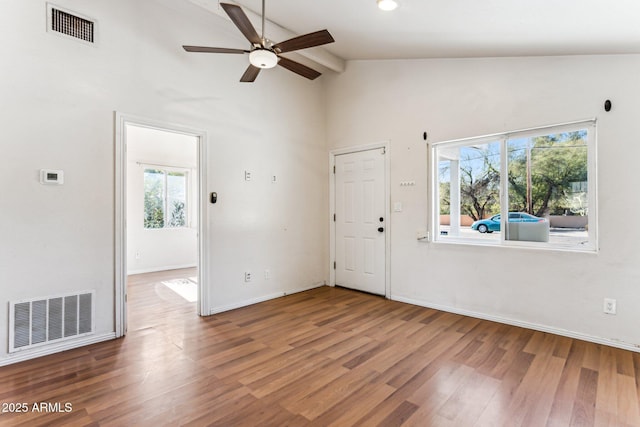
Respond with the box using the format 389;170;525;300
9;291;95;353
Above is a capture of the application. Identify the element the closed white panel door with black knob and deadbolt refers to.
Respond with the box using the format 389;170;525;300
335;148;387;295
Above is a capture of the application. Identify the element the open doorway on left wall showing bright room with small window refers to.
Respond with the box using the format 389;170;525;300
115;114;209;336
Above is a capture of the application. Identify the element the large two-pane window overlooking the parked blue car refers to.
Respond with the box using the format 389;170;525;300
431;121;596;251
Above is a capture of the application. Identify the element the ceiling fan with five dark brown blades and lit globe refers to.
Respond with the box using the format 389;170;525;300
182;0;335;82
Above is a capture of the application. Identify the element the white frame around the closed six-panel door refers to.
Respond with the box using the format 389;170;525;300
329;141;391;299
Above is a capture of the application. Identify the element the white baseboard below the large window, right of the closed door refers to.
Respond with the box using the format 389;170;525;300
391;295;640;353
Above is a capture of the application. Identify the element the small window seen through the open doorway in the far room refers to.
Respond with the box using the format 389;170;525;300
144;169;187;228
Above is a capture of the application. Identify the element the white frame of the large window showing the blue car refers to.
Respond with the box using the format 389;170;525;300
428;119;598;253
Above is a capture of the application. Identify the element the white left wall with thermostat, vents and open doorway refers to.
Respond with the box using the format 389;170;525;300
0;0;328;364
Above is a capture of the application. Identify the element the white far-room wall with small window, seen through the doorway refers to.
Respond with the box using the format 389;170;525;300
126;125;199;274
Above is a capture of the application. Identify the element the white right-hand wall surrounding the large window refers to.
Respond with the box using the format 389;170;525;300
326;56;640;347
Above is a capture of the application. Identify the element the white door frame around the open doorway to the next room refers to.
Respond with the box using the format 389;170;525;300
114;111;209;337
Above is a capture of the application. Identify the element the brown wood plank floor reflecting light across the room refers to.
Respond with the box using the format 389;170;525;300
0;271;640;426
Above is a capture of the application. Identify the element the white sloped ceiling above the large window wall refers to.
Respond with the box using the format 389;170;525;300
206;0;640;60
